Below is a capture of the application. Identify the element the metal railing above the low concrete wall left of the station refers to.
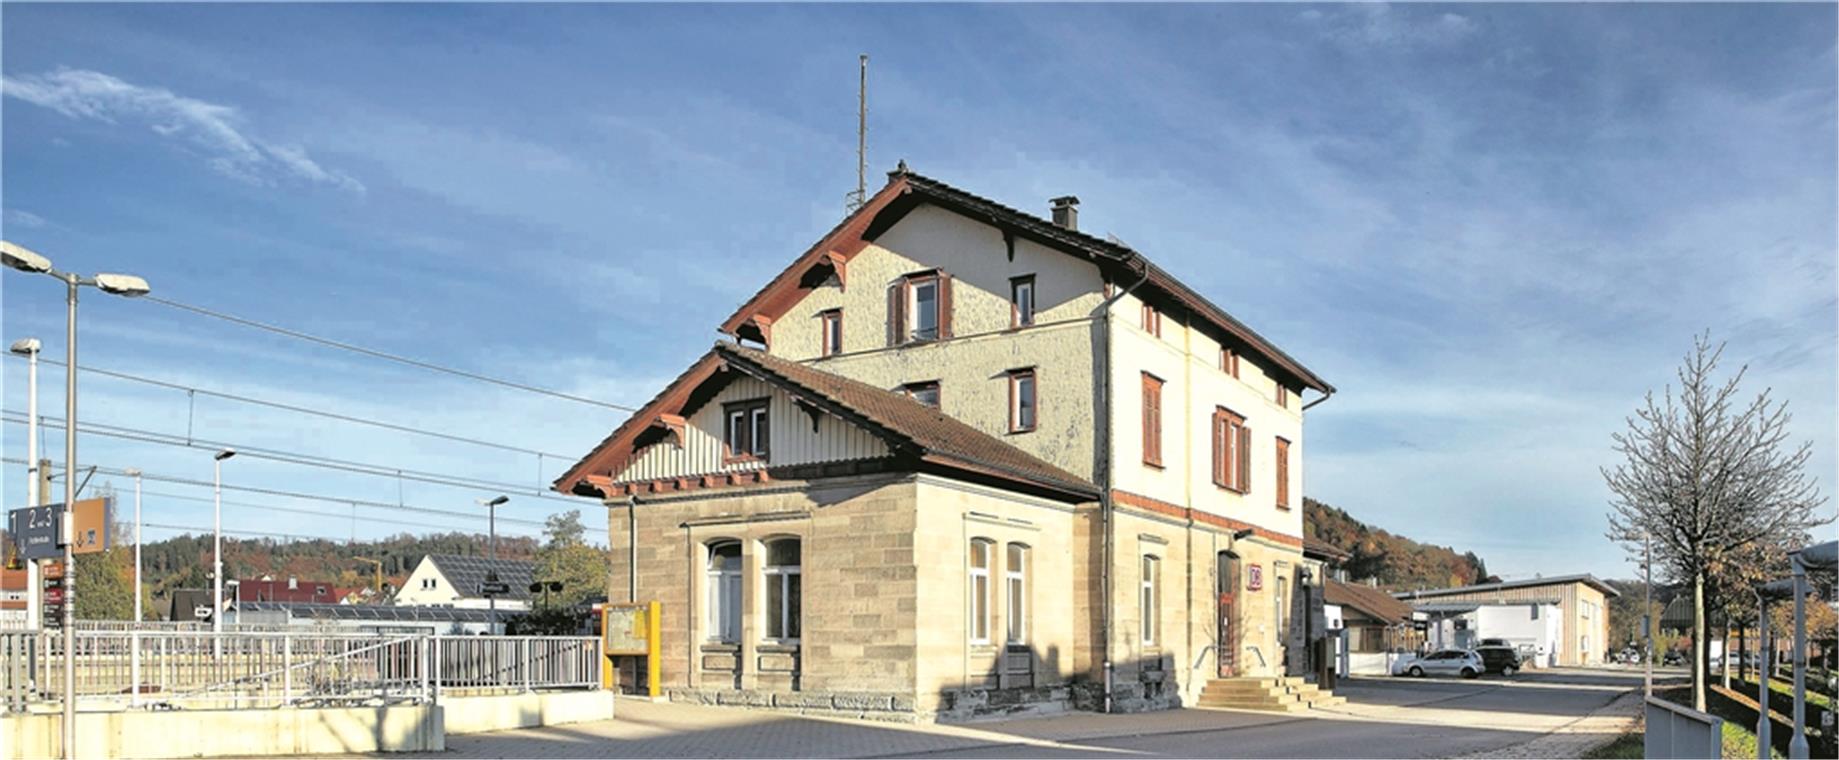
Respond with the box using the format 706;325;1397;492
0;629;601;710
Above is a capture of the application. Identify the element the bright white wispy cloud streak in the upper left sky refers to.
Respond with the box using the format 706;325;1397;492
0;68;364;193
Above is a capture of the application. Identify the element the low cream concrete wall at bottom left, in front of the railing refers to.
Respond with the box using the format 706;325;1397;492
0;705;447;760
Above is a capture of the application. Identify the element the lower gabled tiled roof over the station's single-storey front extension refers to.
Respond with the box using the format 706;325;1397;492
554;342;1098;499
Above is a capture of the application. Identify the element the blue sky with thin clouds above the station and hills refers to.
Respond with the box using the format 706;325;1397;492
0;4;1839;576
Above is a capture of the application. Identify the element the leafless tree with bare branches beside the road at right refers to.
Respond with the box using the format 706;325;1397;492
1604;333;1828;710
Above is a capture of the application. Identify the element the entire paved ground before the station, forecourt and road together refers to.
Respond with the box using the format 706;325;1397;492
384;672;1640;758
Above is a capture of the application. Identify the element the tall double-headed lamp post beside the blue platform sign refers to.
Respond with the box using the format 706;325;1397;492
0;241;151;758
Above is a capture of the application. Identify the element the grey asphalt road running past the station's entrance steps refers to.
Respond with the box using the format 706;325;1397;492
908;672;1640;758
